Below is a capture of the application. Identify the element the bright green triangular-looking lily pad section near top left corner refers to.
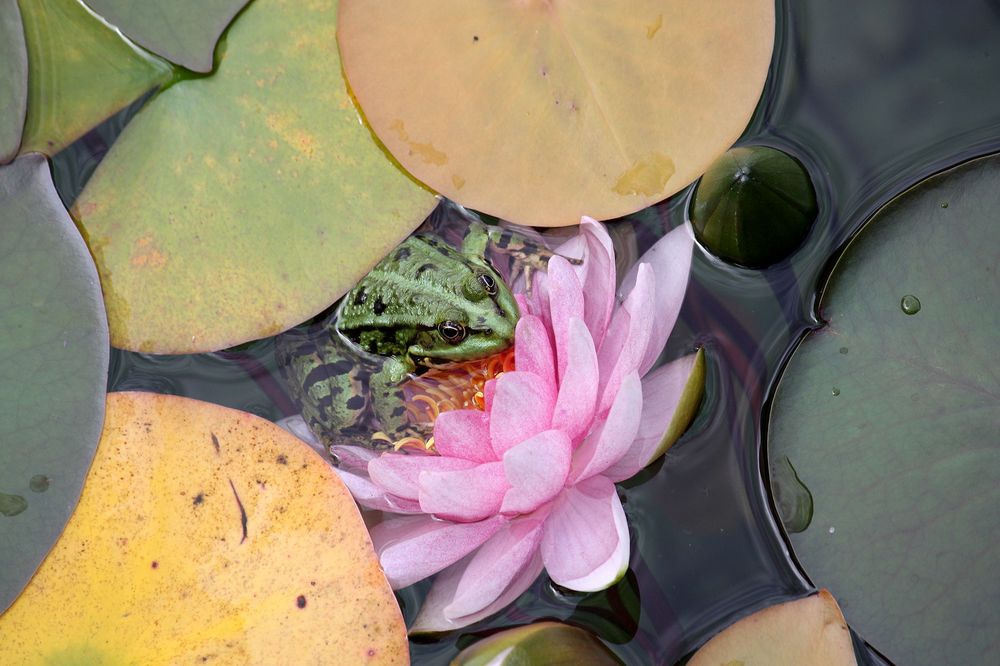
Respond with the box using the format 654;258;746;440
21;0;173;155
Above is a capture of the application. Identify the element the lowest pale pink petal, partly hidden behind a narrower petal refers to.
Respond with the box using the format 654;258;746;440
410;551;542;634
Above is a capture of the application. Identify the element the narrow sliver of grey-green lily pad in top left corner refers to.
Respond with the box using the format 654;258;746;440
0;0;28;164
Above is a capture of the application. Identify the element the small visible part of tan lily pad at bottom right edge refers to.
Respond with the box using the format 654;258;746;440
688;590;857;666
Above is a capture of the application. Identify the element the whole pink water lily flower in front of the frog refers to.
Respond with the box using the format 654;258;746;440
334;217;695;632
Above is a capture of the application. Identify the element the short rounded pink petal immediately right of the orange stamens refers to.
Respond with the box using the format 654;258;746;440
490;370;556;458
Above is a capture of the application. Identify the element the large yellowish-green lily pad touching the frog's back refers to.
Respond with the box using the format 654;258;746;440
74;0;436;353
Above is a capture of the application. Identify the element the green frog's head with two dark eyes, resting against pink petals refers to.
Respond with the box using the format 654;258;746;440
409;256;519;361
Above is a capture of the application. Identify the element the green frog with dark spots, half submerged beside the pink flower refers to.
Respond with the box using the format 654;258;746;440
276;223;521;447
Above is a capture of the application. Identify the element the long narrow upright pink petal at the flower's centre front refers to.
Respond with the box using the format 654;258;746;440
552;317;599;442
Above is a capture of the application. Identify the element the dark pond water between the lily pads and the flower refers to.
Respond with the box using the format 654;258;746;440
53;0;1000;664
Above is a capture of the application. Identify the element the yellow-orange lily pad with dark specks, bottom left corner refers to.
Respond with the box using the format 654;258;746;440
0;393;409;664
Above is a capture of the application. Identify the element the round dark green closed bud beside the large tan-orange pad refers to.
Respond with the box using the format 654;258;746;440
691;146;819;268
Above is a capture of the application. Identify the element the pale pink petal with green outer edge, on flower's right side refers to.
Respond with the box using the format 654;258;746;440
604;354;698;481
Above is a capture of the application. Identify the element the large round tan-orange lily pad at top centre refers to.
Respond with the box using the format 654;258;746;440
338;0;774;226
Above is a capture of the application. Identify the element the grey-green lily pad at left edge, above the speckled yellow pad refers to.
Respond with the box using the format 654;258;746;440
0;154;108;612
